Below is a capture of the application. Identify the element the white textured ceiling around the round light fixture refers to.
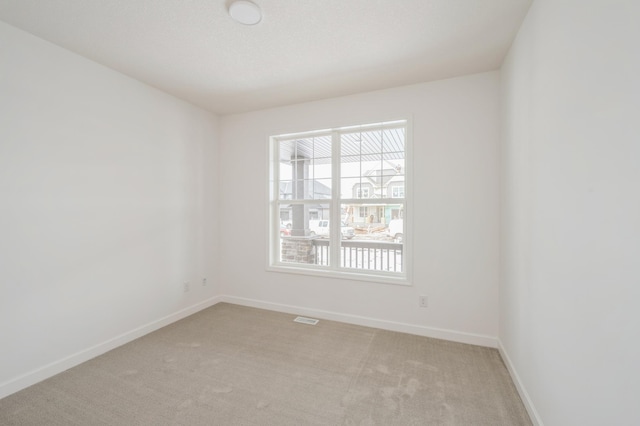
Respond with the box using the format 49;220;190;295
0;0;531;114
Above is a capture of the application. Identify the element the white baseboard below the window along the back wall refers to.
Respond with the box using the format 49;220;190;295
220;296;498;348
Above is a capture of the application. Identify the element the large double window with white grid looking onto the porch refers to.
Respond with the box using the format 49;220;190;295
269;120;410;283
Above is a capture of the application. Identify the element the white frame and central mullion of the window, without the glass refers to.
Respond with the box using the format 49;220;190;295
266;118;413;285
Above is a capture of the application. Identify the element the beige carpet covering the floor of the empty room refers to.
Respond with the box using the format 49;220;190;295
0;303;531;426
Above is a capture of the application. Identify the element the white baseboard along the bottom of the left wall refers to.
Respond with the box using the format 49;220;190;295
0;297;220;399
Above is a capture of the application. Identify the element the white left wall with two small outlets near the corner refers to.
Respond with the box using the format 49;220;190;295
0;22;217;397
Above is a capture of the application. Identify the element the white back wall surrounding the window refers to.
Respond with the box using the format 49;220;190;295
220;72;499;345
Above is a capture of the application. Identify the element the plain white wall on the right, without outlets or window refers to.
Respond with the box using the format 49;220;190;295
500;0;640;426
